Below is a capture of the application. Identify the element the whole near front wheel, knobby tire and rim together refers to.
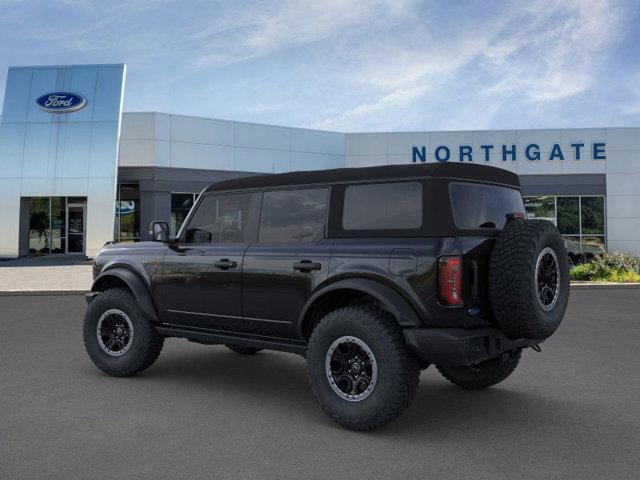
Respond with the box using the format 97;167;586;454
82;288;164;377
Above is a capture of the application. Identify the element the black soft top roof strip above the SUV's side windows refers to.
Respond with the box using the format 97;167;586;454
206;163;520;192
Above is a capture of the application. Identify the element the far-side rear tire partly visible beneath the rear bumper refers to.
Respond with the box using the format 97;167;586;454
436;350;522;390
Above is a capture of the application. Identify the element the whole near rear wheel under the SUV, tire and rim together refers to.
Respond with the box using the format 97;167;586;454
307;305;420;431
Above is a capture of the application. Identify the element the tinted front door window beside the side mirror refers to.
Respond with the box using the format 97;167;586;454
185;193;253;243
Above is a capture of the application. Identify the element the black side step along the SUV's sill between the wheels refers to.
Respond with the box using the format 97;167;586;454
156;325;307;355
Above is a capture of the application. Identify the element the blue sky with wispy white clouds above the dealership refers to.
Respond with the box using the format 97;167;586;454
0;0;640;131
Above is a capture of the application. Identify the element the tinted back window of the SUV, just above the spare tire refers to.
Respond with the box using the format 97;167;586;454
449;182;524;230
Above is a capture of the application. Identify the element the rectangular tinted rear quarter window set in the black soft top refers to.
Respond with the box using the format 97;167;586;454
342;182;422;230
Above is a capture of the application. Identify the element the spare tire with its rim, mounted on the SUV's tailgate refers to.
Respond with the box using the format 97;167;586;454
489;220;569;340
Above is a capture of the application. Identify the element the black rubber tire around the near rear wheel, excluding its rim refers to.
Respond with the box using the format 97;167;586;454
306;304;420;431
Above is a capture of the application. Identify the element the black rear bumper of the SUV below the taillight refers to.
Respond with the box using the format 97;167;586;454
403;327;541;367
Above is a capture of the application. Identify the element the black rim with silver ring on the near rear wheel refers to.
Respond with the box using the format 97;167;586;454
325;336;378;402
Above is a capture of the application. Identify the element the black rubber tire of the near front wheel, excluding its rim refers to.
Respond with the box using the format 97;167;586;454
82;288;164;377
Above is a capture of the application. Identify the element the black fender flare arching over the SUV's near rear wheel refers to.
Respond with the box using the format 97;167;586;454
298;278;422;338
